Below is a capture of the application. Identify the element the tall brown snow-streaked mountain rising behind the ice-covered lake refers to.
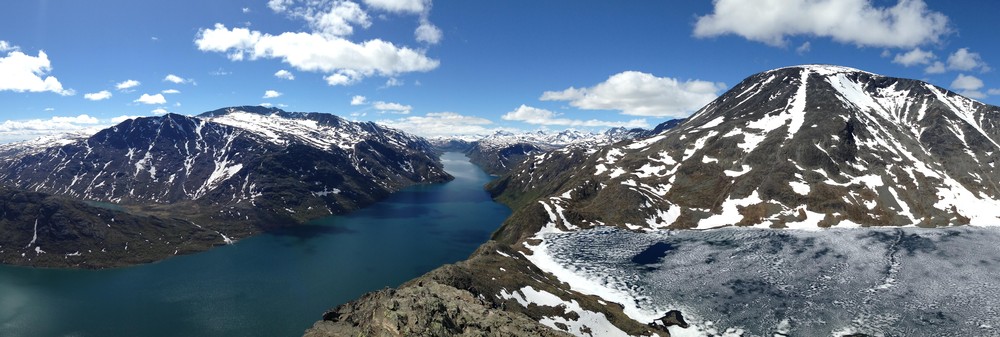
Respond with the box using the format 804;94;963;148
495;65;1000;228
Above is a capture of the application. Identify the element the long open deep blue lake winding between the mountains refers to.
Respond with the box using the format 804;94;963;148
0;153;510;337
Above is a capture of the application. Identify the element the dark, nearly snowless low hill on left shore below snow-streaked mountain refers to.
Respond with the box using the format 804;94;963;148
0;186;225;268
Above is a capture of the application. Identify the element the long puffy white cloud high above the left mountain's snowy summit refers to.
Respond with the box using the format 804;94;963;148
195;24;440;85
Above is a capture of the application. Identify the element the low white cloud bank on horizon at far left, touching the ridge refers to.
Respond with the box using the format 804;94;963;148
0;115;100;142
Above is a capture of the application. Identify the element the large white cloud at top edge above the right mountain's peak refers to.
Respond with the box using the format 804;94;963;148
694;0;950;48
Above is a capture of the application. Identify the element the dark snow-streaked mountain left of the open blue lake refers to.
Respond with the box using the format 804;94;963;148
0;107;451;266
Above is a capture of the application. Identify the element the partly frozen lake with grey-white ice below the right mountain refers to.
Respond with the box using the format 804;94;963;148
545;227;1000;336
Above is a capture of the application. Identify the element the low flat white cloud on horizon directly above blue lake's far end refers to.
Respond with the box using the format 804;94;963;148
378;112;497;137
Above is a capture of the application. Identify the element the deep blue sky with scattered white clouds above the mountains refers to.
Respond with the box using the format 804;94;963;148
0;0;1000;142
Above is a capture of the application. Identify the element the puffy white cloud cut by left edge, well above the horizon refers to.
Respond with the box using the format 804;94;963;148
0;47;76;96
